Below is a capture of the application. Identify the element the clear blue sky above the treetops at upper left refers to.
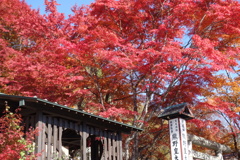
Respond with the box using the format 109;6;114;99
25;0;95;16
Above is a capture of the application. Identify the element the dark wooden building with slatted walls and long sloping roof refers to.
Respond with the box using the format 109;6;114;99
0;94;141;160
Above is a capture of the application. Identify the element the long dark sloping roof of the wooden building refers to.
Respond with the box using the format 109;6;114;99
0;93;142;133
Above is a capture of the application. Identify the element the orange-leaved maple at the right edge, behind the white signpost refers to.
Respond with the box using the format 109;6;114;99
195;72;240;158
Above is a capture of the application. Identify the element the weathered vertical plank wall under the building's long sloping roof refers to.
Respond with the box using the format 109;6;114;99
24;112;123;160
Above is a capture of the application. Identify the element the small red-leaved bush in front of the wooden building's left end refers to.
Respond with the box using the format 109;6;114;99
0;107;37;160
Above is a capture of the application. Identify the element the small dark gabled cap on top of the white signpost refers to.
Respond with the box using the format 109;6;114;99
158;103;194;120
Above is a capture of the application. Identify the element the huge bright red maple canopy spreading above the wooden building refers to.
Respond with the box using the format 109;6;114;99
0;0;240;159
